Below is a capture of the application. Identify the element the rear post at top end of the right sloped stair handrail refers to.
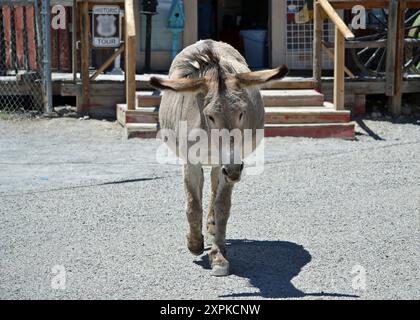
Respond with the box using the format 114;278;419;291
313;1;323;91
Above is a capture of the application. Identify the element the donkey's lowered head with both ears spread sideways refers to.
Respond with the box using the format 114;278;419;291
150;63;288;182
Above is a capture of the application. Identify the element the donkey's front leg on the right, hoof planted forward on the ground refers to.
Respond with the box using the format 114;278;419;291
209;173;234;276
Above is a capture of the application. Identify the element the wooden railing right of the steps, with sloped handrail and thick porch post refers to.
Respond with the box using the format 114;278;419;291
313;0;420;116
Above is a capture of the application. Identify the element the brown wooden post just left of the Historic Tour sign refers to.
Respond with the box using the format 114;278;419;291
78;1;90;113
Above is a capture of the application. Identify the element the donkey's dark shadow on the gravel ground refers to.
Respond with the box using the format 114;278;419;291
195;240;358;298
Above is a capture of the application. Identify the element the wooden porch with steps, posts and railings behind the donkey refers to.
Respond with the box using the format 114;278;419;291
65;0;420;138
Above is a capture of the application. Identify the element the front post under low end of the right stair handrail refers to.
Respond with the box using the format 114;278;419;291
334;26;345;110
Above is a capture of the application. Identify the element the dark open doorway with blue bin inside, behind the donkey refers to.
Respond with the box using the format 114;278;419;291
197;0;270;69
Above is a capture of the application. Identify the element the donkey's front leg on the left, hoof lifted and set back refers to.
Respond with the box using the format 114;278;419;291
184;164;204;256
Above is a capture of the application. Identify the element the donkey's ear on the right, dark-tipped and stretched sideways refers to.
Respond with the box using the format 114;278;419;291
236;65;289;88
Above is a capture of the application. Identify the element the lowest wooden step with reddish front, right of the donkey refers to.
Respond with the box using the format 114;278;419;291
265;122;355;140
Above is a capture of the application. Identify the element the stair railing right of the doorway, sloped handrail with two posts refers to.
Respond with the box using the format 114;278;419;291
313;0;355;110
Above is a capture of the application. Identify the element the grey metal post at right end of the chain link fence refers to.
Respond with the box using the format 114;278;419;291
42;0;53;114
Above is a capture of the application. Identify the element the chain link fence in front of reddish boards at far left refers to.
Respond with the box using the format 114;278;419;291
0;0;44;114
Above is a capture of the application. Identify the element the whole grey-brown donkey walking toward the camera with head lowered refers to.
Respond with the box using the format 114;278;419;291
150;40;288;276
